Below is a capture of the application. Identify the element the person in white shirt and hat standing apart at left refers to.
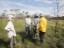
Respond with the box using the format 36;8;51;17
5;15;16;48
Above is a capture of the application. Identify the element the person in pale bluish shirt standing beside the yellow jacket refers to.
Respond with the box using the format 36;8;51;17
33;15;39;40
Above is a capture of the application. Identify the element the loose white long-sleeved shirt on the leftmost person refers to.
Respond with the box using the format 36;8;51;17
5;21;16;38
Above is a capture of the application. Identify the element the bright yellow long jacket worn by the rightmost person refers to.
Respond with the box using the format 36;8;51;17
39;17;47;32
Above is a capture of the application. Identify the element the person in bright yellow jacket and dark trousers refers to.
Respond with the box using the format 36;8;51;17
38;15;47;42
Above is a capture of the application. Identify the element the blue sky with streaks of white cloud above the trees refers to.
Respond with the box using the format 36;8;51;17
0;0;64;16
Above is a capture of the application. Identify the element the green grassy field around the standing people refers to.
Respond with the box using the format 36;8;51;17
0;19;64;48
